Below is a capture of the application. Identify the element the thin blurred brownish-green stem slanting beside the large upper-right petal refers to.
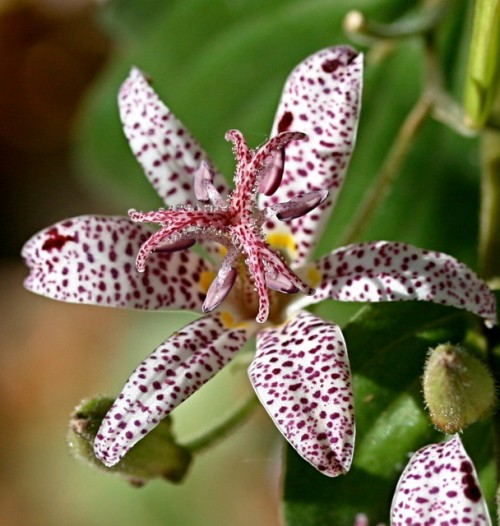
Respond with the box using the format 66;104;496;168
340;93;432;246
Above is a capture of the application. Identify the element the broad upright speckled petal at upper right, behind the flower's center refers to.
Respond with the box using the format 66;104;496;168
261;46;363;264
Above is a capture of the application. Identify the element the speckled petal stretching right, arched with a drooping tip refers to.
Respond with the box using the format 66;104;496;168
297;241;496;322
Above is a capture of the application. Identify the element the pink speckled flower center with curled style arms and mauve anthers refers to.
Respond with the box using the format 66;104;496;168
129;130;327;323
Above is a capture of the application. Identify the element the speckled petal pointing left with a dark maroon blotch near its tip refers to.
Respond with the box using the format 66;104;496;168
22;216;209;311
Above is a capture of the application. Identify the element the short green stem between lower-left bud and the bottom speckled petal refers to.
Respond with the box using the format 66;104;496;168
182;392;259;453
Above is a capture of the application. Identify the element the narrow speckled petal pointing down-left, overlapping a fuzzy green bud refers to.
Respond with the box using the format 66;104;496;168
94;312;252;466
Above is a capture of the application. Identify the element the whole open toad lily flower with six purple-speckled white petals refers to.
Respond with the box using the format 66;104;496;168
23;47;495;476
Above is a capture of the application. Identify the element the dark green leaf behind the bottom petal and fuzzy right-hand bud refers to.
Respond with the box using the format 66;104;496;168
284;302;476;526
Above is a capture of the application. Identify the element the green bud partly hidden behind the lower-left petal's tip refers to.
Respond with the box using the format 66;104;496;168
68;398;191;486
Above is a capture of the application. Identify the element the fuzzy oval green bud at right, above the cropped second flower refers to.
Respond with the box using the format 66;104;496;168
423;343;495;434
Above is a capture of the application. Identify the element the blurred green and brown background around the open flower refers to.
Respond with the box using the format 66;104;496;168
0;0;479;526
